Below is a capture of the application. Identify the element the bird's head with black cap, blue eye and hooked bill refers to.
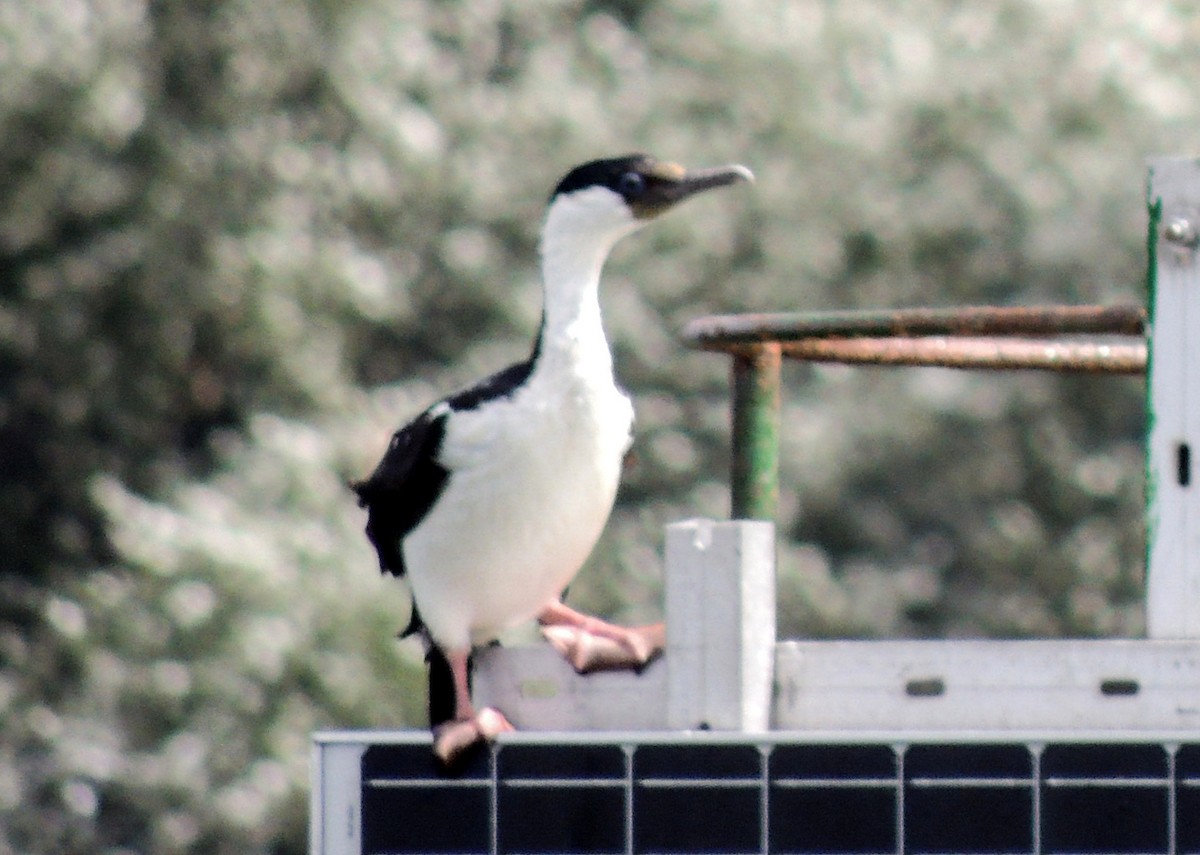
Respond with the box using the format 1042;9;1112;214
546;154;754;250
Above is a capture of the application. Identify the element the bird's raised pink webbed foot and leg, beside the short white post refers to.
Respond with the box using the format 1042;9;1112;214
538;600;666;674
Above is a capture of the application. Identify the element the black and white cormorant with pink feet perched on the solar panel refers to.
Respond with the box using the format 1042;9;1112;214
354;154;752;763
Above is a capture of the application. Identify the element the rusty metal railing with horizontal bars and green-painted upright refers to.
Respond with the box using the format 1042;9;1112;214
683;305;1146;520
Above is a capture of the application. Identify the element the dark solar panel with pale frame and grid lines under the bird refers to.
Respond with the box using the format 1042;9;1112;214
313;733;1200;855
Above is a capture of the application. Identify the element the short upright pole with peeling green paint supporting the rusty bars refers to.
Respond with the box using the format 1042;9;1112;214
730;342;782;521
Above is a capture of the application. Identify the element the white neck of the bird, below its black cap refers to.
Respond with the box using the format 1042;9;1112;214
539;187;637;376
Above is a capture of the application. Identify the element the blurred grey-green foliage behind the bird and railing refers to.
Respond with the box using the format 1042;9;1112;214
0;0;1185;854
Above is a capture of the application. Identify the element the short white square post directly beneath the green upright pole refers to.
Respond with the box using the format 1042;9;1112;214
665;520;775;731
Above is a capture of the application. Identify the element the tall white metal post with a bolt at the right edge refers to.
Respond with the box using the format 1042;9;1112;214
1146;153;1200;639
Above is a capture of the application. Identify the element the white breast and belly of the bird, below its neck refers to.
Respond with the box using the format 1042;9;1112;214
403;366;632;648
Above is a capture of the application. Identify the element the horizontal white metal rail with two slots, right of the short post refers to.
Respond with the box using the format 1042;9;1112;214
774;640;1200;740
